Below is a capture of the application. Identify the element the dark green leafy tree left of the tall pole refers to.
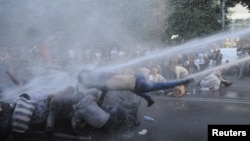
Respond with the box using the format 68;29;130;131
164;0;221;44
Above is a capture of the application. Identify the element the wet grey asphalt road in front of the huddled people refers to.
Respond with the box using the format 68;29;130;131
5;77;250;141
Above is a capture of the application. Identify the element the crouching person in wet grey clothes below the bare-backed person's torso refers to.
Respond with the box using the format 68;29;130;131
71;89;139;132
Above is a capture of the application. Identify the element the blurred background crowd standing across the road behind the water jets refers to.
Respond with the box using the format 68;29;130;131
0;41;236;96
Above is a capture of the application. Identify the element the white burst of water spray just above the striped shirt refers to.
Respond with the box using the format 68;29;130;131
2;71;76;102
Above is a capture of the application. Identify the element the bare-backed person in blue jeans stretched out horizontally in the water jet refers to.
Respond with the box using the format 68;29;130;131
77;69;193;107
